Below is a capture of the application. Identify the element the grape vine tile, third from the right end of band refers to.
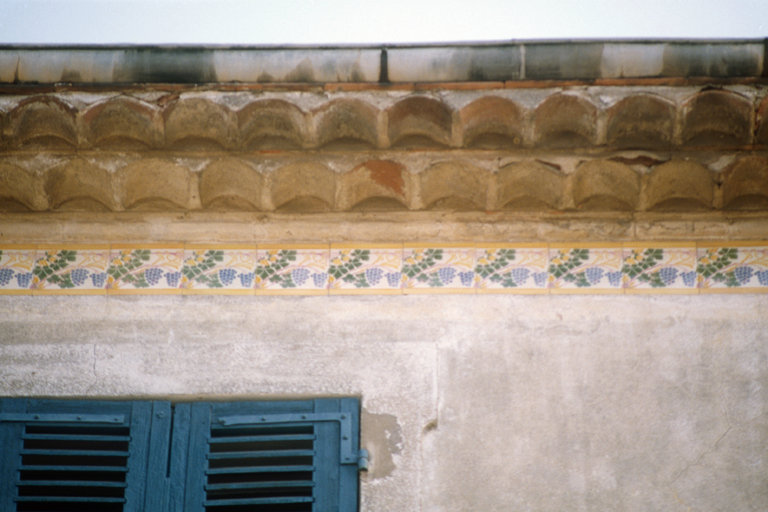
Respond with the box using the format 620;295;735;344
548;244;623;293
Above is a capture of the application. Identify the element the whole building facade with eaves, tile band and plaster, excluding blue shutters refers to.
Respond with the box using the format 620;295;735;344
0;41;768;512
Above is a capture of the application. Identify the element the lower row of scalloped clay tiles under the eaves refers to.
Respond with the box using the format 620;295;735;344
0;151;768;214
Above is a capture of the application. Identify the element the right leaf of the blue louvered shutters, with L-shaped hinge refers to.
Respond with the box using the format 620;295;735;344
177;399;359;512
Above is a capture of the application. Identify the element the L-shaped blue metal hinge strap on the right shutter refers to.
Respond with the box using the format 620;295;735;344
218;413;368;471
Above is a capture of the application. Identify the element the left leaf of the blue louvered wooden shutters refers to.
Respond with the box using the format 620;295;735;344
0;399;168;512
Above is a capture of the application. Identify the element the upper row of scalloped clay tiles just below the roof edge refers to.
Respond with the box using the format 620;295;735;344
0;84;766;153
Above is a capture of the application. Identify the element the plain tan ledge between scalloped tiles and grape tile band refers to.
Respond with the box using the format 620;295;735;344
0;212;768;244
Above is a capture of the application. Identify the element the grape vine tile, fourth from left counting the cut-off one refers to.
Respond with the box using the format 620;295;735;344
181;245;256;294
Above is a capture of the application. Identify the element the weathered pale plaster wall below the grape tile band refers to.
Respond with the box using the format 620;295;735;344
0;294;768;512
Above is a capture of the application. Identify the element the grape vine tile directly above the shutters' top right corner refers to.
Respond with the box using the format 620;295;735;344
328;244;403;294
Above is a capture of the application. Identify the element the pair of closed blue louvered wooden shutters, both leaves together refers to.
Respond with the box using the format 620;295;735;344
0;399;359;512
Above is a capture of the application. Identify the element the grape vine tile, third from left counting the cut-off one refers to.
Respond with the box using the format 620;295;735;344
106;244;184;293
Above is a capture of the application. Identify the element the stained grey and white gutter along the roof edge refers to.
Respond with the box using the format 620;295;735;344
0;39;768;84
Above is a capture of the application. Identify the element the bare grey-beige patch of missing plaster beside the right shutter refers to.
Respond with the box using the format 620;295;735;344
360;409;403;481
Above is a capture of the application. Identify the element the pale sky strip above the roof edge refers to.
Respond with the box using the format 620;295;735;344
0;0;768;45
